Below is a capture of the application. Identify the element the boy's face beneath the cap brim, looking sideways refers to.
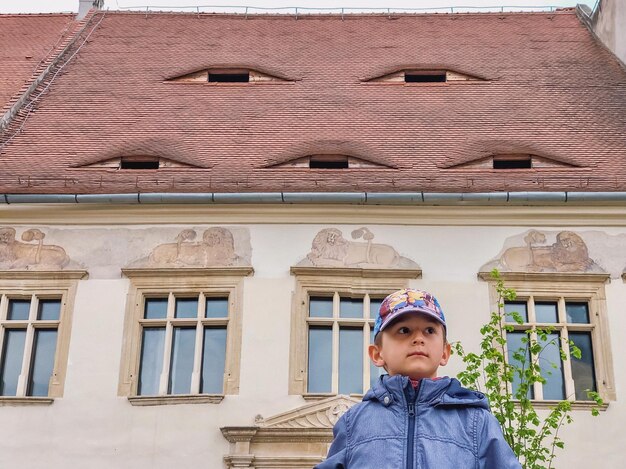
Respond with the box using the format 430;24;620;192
369;313;450;379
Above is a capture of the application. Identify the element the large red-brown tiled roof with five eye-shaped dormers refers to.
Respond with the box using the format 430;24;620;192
0;10;626;193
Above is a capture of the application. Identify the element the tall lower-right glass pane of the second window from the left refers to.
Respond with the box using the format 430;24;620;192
200;327;226;394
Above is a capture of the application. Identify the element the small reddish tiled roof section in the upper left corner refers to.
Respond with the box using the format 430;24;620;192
0;14;74;113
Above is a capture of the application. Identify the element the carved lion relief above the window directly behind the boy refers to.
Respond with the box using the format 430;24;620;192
298;227;417;268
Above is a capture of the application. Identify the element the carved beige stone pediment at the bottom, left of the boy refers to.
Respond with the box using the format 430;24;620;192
221;395;359;469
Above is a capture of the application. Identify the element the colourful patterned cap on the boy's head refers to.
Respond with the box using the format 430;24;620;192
374;288;446;338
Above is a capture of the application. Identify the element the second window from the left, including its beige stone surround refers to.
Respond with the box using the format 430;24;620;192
119;267;252;405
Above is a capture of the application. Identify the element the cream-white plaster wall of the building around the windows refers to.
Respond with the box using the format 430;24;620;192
0;224;626;469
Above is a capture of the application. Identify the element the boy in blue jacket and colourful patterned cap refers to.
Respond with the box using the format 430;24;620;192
316;289;521;469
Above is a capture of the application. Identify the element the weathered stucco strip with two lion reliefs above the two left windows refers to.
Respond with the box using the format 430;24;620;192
0;226;252;279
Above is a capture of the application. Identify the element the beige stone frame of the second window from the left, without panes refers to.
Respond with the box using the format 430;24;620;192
118;267;253;406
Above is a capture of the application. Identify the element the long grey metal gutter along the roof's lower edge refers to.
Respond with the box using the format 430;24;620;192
0;192;626;205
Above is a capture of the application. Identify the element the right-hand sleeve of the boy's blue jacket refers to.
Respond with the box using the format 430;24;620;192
478;412;522;469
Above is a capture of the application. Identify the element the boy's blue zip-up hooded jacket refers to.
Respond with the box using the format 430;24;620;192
315;375;521;469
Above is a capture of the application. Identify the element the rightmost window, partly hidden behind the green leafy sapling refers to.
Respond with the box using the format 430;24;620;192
486;274;615;406
